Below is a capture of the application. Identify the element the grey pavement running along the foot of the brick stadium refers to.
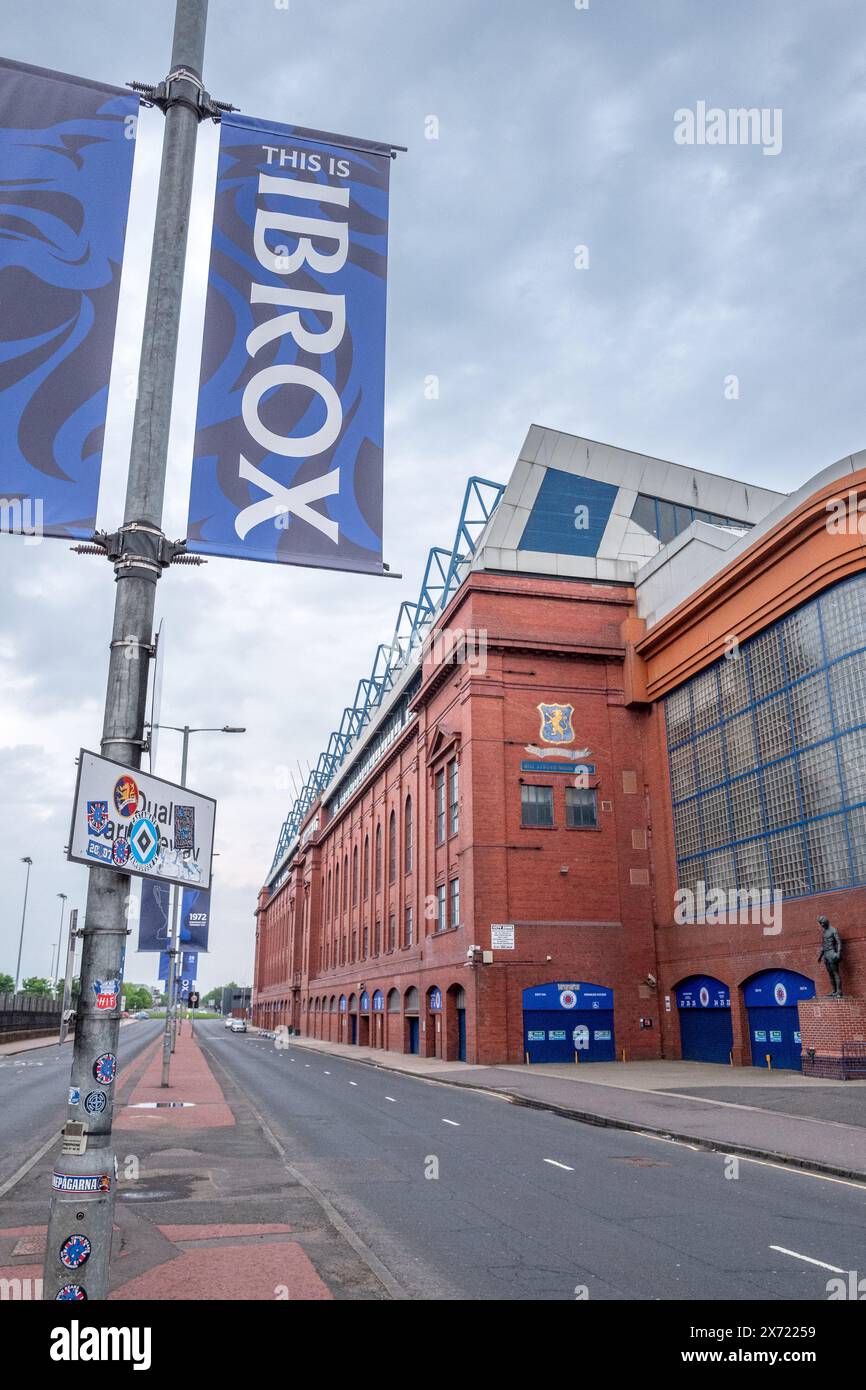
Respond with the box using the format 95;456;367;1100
273;1037;866;1182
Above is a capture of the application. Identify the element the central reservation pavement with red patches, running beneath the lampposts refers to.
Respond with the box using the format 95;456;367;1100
0;1024;388;1301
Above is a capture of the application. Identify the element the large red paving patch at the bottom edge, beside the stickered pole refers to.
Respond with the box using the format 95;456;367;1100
108;1240;334;1302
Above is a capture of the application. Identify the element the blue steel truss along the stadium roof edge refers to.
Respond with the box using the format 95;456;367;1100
271;477;505;873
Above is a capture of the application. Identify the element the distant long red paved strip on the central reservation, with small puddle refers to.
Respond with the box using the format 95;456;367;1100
114;1033;235;1131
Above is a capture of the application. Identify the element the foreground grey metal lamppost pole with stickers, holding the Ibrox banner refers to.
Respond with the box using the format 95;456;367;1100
43;0;214;1301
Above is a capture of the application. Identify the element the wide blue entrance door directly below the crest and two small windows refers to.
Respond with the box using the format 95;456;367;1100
523;981;616;1062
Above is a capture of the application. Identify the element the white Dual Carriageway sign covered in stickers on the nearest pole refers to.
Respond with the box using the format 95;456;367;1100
67;748;217;890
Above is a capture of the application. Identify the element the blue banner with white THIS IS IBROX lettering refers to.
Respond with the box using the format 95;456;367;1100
188;115;391;574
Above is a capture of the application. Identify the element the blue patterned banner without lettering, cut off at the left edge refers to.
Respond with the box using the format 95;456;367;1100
0;58;139;537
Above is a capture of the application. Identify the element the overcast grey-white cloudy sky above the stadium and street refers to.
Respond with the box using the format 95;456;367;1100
0;0;866;990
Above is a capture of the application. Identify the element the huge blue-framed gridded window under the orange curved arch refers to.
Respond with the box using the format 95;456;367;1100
664;575;866;898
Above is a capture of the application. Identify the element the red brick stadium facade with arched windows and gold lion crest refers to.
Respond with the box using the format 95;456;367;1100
253;427;866;1065
